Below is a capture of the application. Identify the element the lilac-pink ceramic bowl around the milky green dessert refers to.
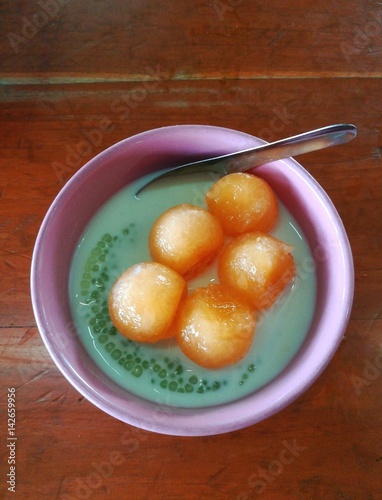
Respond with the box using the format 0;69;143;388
31;125;354;436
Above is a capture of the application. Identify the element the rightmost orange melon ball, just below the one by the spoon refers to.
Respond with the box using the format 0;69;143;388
218;232;295;310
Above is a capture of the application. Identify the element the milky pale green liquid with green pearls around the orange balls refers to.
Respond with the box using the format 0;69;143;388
69;174;316;408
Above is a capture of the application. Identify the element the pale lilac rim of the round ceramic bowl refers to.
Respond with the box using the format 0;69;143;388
31;125;354;436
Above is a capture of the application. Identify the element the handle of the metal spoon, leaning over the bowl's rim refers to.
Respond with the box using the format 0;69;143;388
224;124;357;173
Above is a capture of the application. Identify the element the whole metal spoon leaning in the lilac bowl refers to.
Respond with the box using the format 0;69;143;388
135;124;357;196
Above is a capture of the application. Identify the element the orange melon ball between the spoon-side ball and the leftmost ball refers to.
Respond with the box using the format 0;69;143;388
149;204;224;279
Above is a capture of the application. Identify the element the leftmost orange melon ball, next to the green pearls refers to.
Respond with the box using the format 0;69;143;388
109;262;187;342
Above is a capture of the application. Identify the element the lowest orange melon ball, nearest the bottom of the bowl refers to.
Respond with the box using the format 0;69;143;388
176;284;256;369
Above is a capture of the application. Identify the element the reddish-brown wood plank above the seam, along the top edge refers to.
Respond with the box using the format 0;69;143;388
0;0;382;80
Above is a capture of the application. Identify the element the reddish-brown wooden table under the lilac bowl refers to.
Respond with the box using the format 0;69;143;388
0;0;382;500
